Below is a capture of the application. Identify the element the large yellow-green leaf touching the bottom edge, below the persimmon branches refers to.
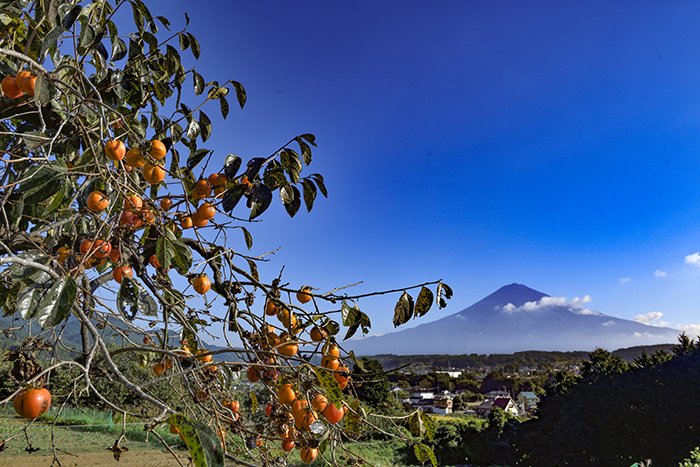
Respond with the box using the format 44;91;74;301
168;414;224;467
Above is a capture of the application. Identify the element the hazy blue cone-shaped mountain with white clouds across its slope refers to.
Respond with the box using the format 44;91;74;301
346;284;679;355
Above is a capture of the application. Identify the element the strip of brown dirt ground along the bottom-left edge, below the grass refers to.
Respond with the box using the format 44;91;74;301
0;451;189;467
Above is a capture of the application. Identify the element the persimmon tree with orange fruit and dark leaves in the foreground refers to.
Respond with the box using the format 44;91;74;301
0;0;452;466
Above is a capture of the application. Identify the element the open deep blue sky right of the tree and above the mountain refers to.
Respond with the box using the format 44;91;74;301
153;0;700;333
